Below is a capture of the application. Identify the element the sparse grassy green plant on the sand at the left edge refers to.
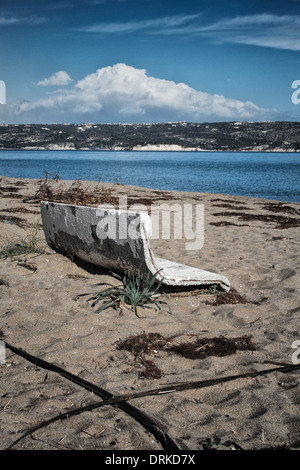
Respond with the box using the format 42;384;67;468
0;225;44;259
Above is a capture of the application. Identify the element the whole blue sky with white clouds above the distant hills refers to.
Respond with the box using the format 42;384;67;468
0;0;300;124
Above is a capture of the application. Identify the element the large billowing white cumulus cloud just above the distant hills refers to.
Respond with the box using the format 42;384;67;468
0;64;272;123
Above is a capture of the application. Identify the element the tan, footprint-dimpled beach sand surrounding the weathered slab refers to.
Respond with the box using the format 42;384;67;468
0;177;300;451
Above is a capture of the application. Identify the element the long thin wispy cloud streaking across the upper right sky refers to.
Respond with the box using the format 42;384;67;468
76;13;300;51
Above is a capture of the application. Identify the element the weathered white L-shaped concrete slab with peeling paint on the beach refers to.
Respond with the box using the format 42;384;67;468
41;202;230;290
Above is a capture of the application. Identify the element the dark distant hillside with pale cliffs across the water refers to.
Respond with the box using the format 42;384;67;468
0;122;300;152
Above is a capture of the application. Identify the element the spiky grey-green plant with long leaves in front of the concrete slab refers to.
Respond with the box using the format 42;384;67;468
88;271;172;318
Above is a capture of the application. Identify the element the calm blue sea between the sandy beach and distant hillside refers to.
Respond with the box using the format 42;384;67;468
0;150;300;203
